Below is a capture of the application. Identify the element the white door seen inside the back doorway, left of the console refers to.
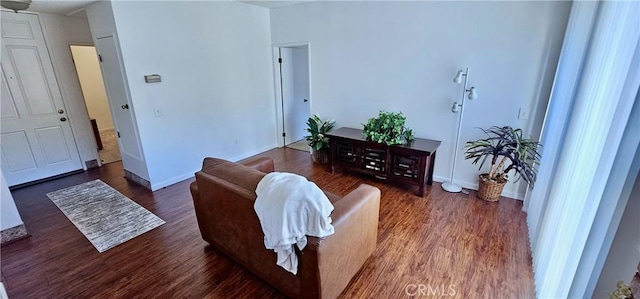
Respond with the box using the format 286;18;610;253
280;46;311;145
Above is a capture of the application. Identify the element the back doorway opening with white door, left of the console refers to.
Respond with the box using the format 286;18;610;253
274;44;311;151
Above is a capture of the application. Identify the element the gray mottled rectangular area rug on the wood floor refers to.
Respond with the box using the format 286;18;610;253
47;180;165;252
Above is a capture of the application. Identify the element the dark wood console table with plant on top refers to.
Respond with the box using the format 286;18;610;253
327;128;441;196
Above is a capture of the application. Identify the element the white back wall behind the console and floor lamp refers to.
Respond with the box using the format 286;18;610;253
271;1;571;198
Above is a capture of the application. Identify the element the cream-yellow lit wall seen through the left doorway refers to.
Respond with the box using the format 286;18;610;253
71;46;113;130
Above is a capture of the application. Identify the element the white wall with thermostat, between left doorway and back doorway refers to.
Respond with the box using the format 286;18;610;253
106;1;276;189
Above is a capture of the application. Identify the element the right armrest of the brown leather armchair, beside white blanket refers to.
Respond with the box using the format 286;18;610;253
300;184;380;298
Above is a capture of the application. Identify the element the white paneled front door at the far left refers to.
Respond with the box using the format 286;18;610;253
0;11;82;186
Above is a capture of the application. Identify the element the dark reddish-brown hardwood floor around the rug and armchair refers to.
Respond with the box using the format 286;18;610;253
1;149;534;299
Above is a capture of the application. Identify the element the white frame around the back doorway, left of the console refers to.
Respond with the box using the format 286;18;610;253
272;41;313;147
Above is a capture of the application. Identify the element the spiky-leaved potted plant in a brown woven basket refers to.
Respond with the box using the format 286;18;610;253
465;126;541;201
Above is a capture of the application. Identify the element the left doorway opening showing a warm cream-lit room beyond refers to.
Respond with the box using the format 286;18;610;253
70;45;122;164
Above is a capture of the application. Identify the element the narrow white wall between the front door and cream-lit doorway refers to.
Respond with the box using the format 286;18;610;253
38;13;98;167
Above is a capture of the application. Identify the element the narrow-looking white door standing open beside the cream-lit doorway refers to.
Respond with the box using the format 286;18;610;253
96;36;146;171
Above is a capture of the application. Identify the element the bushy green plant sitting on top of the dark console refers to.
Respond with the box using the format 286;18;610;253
362;110;415;145
